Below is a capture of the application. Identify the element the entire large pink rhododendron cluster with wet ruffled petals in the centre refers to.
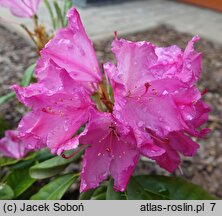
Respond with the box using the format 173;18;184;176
5;8;210;192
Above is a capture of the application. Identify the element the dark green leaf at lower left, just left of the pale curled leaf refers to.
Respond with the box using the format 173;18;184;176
6;168;36;197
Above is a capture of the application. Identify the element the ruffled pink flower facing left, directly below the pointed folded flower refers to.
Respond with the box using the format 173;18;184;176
13;60;92;154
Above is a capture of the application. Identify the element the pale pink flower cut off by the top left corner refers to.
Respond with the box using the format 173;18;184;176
0;0;41;18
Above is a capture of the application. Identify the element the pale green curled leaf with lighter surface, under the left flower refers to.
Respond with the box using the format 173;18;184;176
30;148;83;179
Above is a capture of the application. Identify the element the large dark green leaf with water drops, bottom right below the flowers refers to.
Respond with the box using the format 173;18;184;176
136;175;216;200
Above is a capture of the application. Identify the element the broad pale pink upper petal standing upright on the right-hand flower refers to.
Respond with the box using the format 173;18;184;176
108;39;157;93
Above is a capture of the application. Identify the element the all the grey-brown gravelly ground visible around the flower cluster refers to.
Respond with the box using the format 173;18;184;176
0;26;222;198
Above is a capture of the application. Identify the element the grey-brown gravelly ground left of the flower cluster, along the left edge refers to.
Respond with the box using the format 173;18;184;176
0;25;36;127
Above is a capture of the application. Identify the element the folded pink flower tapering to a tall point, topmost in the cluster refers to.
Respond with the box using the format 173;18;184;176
36;8;102;91
